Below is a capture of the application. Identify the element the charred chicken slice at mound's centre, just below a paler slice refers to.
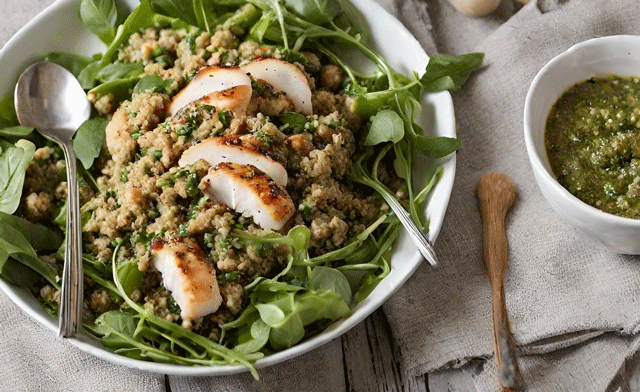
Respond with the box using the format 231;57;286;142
200;162;295;231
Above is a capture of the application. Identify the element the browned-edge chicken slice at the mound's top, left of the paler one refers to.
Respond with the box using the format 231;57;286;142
169;65;251;117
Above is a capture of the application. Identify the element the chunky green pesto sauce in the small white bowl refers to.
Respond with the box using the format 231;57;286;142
545;75;640;219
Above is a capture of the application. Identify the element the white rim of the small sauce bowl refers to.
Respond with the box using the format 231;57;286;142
523;35;640;229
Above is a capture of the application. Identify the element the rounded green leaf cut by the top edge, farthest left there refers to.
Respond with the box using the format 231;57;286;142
80;0;118;45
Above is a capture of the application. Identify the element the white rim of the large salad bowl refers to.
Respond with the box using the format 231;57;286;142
0;0;456;377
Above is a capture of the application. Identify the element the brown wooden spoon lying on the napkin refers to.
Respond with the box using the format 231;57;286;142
476;172;523;391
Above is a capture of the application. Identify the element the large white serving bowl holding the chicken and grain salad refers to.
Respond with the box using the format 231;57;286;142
0;0;456;376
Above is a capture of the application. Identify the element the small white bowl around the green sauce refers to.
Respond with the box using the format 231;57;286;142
524;35;640;254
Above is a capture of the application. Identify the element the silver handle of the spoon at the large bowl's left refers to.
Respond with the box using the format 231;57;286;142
58;141;83;338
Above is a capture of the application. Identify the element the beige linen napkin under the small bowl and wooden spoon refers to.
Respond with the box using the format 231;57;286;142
384;0;640;391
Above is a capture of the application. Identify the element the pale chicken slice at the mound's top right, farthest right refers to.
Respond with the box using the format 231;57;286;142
242;58;313;116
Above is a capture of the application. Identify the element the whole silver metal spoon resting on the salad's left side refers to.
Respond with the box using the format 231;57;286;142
15;61;91;337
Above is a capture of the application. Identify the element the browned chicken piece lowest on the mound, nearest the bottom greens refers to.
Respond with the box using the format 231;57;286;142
151;237;222;320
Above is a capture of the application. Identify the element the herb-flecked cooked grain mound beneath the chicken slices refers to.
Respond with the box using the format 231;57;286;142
20;22;393;340
